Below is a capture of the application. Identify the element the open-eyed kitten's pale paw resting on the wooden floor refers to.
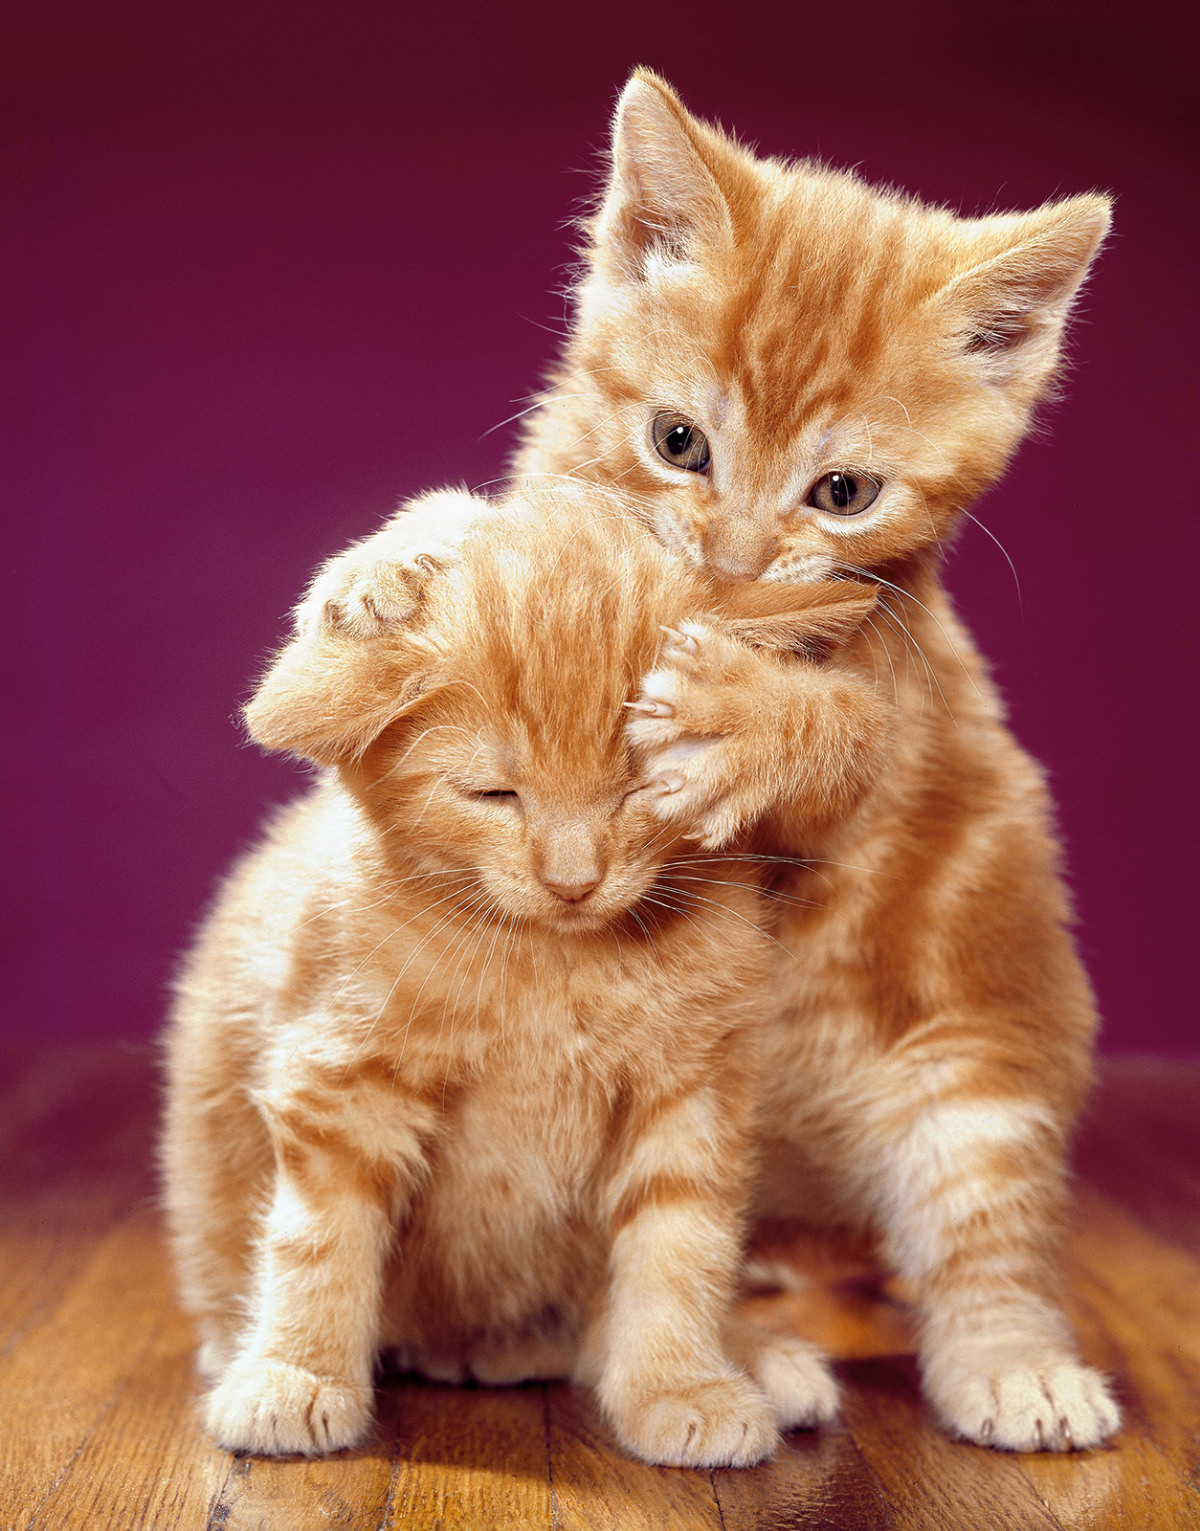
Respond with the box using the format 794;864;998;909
926;1356;1120;1451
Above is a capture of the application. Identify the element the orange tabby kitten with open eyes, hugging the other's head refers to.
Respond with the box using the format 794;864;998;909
332;70;1119;1450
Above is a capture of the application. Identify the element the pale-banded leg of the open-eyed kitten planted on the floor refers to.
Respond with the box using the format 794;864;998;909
879;1098;1120;1451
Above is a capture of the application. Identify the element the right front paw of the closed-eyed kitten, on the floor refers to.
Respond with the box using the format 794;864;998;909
608;1375;779;1467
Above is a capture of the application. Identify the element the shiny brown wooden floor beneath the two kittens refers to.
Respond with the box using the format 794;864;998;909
0;1050;1200;1531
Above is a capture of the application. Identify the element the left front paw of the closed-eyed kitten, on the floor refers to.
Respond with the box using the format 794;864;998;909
205;1360;370;1456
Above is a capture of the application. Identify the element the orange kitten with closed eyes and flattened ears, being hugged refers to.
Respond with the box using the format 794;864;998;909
162;487;885;1465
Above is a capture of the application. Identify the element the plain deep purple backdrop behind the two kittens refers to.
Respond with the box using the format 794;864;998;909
0;0;1200;1053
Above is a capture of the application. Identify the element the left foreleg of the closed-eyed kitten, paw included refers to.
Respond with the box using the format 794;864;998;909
207;1083;416;1456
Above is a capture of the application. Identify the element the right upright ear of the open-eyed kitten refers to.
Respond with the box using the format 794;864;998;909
940;196;1111;401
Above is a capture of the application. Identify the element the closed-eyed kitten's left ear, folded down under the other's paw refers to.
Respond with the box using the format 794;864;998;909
242;632;429;766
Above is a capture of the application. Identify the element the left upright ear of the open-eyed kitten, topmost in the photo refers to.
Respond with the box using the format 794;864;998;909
592;69;730;282
